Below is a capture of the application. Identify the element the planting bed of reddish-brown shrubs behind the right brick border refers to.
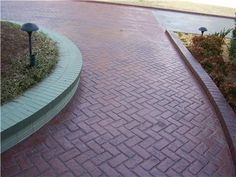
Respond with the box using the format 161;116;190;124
177;31;236;112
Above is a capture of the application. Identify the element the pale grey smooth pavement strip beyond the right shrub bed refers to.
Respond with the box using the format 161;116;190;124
153;10;234;36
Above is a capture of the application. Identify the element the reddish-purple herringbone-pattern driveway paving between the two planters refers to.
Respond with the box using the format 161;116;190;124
1;2;235;177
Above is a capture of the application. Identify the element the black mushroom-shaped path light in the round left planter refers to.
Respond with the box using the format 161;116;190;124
21;23;39;66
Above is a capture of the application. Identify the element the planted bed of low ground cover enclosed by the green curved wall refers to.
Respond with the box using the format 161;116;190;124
1;21;58;105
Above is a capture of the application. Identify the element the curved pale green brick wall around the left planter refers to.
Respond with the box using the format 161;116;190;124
1;23;82;152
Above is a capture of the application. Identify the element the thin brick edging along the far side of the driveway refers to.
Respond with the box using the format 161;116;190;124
81;0;234;19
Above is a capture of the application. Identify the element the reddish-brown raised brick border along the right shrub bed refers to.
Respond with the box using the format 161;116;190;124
166;30;236;166
